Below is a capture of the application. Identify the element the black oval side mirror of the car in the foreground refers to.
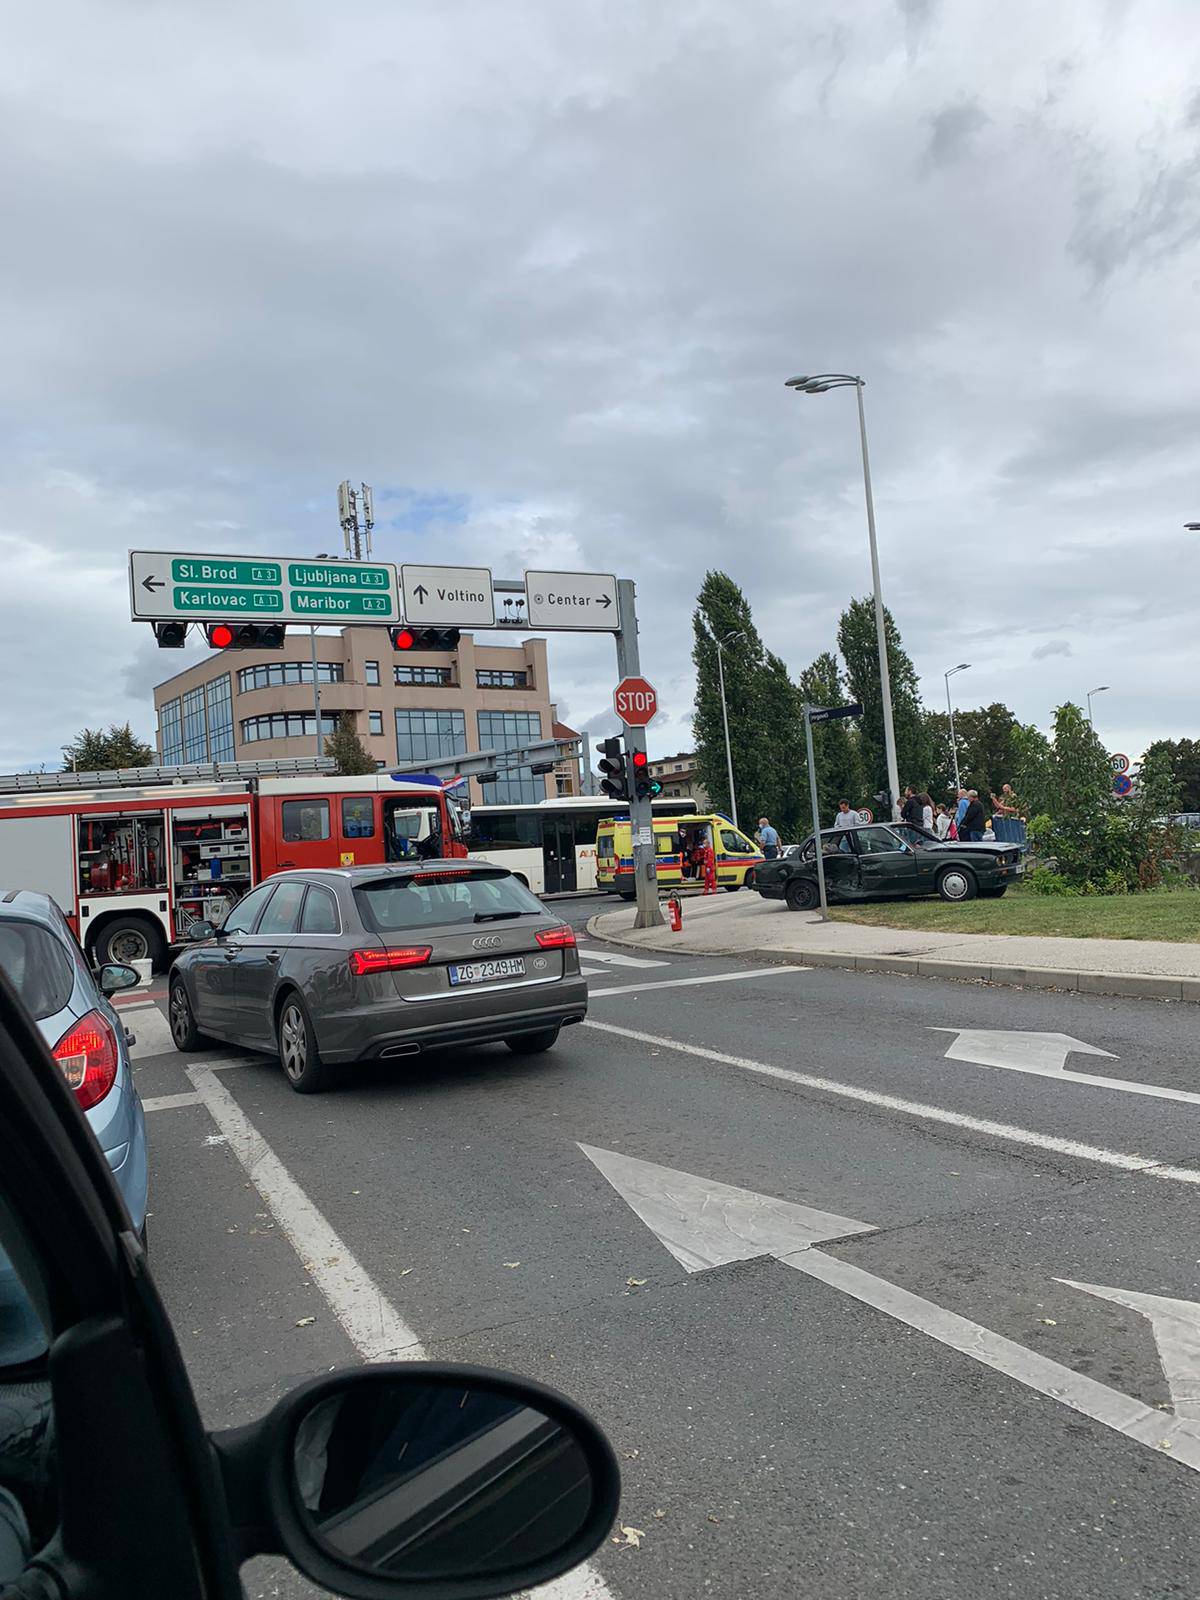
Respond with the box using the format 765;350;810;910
213;1362;621;1600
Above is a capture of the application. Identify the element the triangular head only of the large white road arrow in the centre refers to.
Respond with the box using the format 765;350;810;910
579;1144;875;1272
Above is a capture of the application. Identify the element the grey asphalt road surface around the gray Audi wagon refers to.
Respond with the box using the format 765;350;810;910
120;901;1200;1600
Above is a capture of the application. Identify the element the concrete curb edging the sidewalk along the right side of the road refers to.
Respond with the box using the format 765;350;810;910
587;912;1200;1003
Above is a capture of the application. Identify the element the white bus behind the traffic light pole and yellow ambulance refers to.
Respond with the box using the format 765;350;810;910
464;795;696;894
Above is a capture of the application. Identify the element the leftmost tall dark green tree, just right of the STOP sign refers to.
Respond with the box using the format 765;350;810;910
691;571;781;832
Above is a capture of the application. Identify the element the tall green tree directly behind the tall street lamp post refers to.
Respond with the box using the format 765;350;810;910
837;597;934;798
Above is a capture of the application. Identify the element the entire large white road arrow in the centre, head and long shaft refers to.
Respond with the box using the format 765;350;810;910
592;1146;1200;1472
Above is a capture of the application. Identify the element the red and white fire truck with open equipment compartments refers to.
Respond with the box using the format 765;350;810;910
0;757;467;966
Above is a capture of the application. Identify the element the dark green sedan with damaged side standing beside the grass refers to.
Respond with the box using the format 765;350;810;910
754;822;1024;910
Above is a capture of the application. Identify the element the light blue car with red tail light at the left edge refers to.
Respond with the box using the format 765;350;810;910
0;890;147;1365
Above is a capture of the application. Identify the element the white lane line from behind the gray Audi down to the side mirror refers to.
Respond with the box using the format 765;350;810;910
187;1061;614;1600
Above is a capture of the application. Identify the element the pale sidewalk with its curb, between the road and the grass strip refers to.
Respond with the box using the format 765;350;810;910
587;890;1200;1002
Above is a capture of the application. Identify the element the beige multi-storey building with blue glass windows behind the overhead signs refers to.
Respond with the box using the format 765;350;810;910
154;627;569;805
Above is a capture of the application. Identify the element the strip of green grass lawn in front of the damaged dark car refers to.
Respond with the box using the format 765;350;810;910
829;890;1200;944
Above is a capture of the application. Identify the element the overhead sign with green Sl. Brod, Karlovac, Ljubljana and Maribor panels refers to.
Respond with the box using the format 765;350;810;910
130;550;400;626
